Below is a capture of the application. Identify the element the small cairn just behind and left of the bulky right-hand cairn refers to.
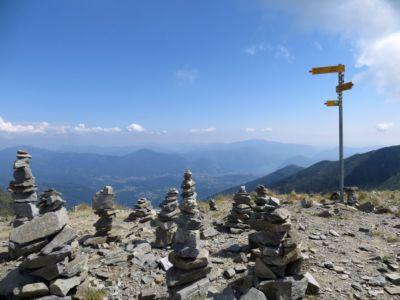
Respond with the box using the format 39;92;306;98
225;186;254;233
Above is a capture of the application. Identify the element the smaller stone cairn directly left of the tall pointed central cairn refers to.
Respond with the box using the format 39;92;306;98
155;188;179;248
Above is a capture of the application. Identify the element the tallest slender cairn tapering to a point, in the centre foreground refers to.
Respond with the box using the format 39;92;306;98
166;170;211;300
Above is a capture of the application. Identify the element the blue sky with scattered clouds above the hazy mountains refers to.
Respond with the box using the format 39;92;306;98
0;0;400;146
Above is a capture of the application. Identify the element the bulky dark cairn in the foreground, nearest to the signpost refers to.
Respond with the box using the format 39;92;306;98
249;203;308;299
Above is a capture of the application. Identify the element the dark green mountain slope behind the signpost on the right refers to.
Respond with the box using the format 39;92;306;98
217;146;400;194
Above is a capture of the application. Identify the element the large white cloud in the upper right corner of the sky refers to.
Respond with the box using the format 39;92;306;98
263;0;400;101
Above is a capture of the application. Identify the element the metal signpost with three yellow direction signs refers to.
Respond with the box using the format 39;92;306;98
310;65;353;202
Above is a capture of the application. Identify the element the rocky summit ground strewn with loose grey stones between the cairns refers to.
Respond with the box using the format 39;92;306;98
0;196;400;299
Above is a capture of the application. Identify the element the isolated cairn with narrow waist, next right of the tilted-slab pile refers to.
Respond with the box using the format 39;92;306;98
84;186;120;246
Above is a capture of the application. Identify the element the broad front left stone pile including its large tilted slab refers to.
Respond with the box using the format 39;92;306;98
0;189;87;299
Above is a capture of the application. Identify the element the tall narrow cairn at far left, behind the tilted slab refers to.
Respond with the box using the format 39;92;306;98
8;150;39;227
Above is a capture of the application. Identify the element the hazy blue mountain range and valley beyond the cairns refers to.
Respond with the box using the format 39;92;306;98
0;140;384;206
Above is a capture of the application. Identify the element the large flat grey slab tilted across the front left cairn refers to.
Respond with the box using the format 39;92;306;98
10;208;69;244
